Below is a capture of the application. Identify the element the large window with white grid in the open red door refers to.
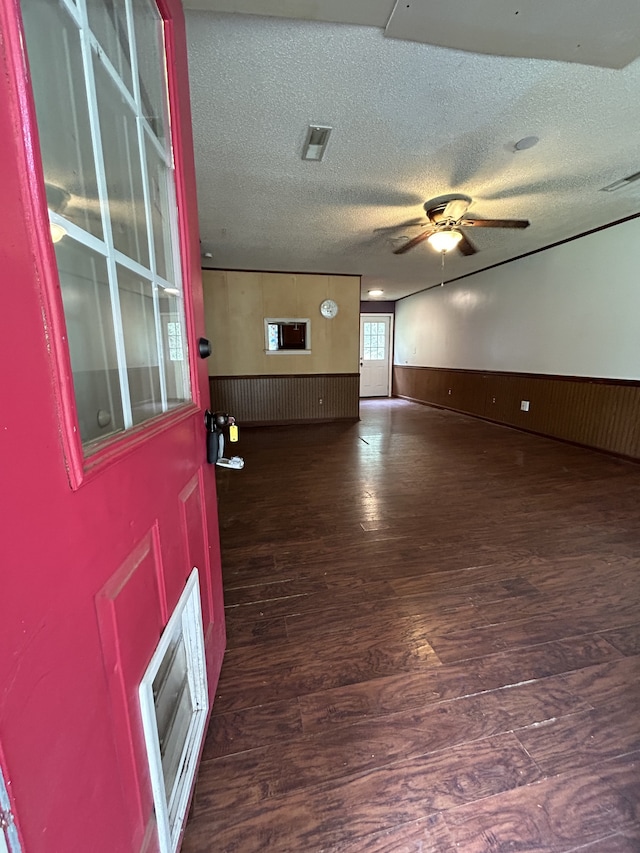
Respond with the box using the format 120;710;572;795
21;0;191;453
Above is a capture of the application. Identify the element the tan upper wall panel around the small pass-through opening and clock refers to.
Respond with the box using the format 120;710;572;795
202;270;360;376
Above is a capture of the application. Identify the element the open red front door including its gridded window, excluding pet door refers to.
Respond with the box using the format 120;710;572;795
0;0;224;853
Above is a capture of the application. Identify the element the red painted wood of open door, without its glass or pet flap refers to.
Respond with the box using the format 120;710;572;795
0;0;224;853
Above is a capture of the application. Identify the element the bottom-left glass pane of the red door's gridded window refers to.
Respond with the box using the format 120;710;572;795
56;237;124;444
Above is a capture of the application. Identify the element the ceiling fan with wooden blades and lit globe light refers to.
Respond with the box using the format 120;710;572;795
393;195;529;255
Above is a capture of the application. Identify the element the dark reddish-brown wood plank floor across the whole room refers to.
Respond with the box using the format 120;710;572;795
183;400;640;853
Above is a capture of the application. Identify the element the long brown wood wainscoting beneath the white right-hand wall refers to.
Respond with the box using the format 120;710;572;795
393;365;640;459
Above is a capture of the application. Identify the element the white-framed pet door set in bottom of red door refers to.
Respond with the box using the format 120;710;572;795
139;568;209;853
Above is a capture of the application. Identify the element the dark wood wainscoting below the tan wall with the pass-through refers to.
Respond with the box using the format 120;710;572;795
209;373;360;426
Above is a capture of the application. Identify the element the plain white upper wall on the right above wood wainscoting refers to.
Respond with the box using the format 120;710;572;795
395;219;640;379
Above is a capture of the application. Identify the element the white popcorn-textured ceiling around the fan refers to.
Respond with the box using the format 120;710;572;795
186;0;640;299
